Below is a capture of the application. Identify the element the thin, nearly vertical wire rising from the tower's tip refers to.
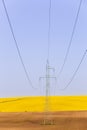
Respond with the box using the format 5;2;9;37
47;0;52;60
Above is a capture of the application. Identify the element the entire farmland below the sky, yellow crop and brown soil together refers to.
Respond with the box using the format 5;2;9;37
0;96;87;130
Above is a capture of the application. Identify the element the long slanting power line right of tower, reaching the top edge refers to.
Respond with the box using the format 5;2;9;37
58;0;83;78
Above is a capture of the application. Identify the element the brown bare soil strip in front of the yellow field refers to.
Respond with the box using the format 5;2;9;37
0;111;87;130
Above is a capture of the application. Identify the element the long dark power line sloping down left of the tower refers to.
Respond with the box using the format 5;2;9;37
2;0;36;89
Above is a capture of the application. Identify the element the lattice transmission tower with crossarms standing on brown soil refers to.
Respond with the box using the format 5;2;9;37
39;60;56;125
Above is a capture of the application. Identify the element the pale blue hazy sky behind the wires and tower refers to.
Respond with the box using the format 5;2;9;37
0;0;87;97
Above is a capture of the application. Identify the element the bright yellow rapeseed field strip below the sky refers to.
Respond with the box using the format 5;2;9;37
0;96;87;112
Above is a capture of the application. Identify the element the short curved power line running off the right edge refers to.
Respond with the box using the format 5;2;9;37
60;50;87;90
